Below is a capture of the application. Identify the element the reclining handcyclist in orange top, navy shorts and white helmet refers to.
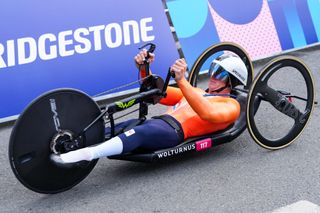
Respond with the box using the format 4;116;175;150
51;50;248;164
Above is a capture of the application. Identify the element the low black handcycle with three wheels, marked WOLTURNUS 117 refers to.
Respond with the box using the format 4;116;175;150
9;42;317;194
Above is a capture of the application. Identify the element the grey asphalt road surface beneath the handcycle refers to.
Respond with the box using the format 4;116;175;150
0;46;320;212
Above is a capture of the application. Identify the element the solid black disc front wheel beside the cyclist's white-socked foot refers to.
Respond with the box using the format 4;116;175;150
9;89;104;194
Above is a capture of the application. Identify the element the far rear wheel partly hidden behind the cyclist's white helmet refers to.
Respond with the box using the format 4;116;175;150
189;42;253;90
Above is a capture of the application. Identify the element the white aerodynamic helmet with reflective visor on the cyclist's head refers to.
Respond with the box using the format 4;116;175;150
209;53;248;88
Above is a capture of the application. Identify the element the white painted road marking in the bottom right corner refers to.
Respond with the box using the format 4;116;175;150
272;200;320;213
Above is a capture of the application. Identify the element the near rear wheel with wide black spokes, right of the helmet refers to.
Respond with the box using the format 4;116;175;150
247;56;314;150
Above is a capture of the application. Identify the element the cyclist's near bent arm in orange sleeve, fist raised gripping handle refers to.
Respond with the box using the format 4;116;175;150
171;59;240;123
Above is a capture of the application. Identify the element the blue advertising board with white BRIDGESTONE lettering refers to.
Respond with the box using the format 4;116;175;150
0;0;179;121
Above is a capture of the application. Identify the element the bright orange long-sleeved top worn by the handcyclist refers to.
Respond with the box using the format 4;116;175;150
160;79;240;139
